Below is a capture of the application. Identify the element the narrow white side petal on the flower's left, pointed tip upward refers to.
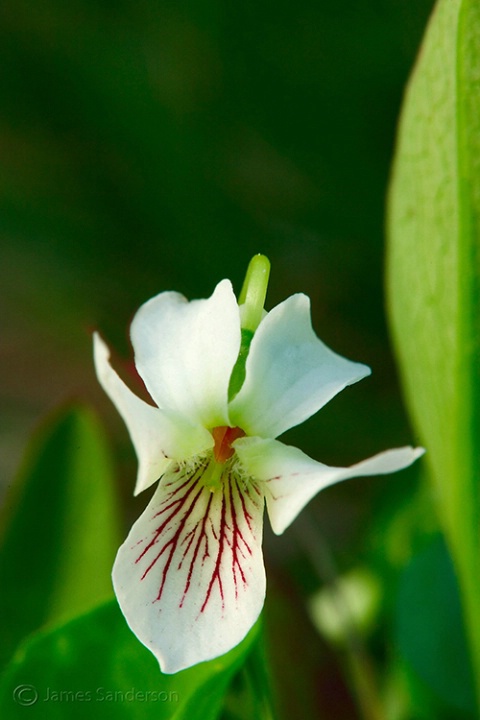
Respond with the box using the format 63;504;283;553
93;333;213;495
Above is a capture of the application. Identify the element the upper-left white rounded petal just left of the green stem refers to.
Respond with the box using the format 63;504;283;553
131;280;240;428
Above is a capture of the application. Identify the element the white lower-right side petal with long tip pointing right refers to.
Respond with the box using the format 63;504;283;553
233;438;424;535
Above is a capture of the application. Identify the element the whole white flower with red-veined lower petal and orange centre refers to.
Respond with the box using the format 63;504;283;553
94;272;423;673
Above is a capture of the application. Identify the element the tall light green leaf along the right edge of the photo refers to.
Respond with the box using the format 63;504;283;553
388;0;480;697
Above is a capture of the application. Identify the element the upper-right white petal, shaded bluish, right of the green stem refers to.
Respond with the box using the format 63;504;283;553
230;294;370;437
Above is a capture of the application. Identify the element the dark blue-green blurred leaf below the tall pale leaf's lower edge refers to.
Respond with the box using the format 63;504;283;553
396;540;475;715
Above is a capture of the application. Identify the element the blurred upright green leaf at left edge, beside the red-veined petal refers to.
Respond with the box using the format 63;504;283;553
0;406;120;660
